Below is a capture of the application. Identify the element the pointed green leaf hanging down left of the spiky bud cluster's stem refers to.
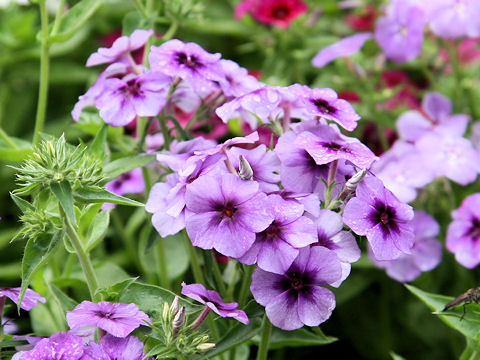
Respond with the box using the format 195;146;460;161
17;231;64;312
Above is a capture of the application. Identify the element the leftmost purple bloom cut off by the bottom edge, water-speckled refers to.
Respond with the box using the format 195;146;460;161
14;332;84;360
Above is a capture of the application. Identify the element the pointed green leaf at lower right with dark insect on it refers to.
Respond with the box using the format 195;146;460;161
405;284;480;342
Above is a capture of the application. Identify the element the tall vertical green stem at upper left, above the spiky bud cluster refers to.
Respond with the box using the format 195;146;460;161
33;0;50;146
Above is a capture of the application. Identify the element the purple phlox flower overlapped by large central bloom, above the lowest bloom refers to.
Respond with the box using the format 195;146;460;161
238;194;317;274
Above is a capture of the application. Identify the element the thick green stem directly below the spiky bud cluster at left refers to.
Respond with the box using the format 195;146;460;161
59;206;98;302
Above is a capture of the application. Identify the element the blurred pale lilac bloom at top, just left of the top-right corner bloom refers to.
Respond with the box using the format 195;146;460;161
375;0;426;63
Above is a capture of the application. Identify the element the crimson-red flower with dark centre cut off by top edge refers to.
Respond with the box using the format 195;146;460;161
235;0;308;28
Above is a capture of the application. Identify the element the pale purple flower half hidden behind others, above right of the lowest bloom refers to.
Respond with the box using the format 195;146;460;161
314;209;361;287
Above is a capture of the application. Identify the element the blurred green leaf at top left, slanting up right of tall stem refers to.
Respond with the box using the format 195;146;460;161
49;0;104;43
